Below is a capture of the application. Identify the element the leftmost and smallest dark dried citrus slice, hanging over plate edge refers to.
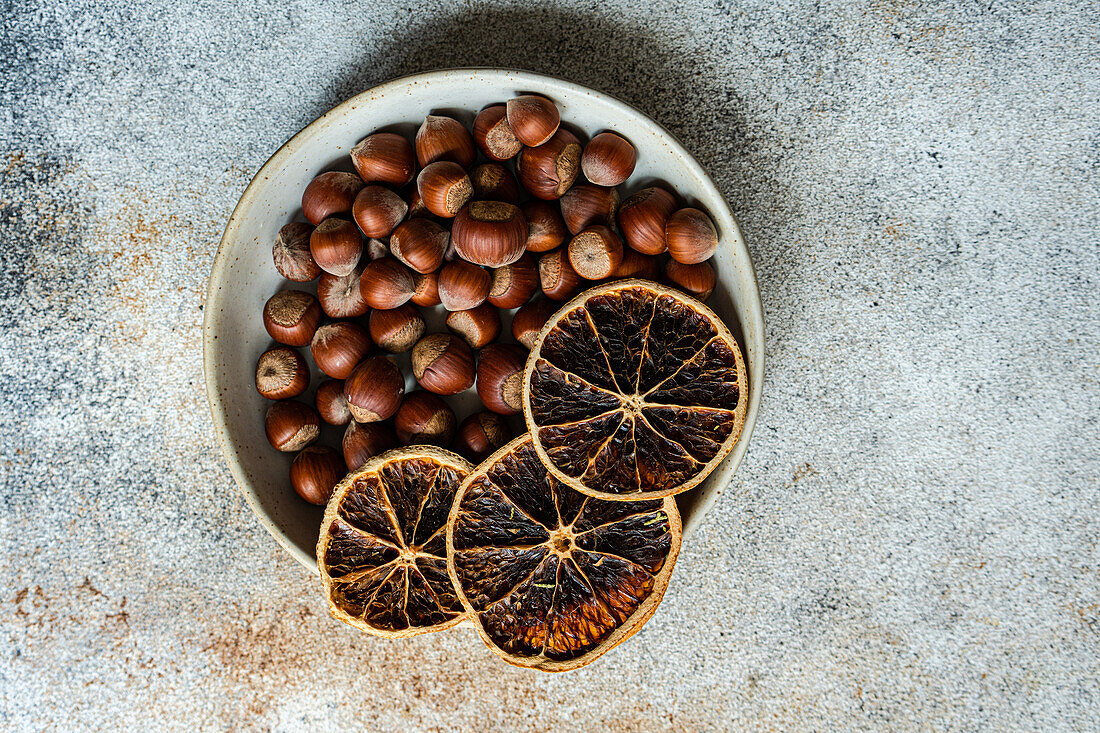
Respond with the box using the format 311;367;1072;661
317;446;471;637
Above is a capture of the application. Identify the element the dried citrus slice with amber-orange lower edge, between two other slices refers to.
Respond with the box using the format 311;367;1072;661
447;435;681;671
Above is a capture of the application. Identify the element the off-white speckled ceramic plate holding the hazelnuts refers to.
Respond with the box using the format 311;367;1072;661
204;69;763;571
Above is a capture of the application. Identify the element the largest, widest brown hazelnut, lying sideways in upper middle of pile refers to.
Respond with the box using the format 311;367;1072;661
444;201;527;267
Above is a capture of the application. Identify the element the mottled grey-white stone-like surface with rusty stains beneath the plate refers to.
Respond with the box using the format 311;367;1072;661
0;0;1100;731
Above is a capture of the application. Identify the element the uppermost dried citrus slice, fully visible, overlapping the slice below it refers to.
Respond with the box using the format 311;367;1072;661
524;280;748;500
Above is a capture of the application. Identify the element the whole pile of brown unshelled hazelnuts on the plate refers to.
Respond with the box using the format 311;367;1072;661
256;95;717;504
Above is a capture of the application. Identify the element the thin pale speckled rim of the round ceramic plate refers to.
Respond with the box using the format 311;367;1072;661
202;66;765;572
